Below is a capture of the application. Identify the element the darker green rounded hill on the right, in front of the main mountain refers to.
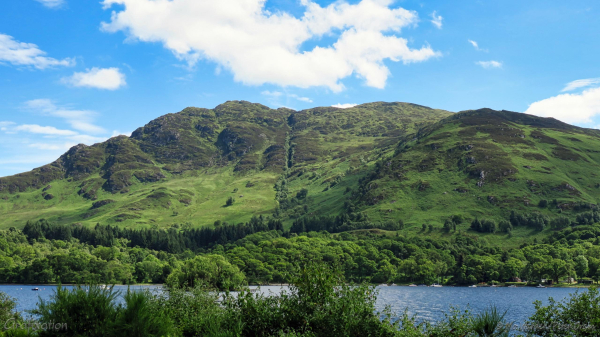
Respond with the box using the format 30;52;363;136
360;111;600;241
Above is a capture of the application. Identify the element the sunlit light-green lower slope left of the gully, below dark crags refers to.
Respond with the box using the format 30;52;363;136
0;168;277;227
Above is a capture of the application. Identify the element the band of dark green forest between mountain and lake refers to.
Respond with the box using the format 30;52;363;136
0;215;600;289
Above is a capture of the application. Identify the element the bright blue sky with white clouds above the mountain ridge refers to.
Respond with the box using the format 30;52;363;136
0;0;600;176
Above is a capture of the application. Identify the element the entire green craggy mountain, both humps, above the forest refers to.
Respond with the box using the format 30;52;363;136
0;101;600;235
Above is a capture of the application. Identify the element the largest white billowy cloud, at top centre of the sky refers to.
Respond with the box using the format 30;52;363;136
101;0;441;92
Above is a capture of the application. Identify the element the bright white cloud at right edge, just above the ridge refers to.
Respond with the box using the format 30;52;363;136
525;88;600;124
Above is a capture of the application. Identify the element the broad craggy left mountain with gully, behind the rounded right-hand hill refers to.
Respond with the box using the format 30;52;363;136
0;102;450;228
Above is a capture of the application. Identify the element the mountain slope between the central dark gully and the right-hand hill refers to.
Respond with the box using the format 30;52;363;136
274;102;451;224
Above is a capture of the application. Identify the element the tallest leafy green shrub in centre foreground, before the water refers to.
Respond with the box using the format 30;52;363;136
224;264;398;337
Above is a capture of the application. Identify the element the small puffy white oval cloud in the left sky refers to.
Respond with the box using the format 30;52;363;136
62;68;126;90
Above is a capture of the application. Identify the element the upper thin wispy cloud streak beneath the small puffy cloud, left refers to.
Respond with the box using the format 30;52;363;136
25;98;106;134
